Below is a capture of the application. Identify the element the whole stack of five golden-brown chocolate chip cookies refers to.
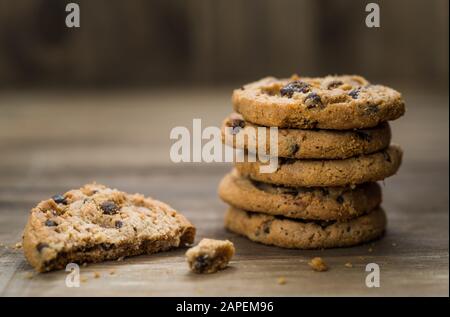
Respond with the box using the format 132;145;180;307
219;76;405;249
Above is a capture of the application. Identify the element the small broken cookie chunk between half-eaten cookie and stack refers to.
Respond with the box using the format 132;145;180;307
186;239;235;273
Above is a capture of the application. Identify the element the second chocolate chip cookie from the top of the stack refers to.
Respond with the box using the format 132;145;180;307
222;113;391;159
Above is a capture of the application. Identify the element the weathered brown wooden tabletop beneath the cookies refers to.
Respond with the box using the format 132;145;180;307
0;90;449;296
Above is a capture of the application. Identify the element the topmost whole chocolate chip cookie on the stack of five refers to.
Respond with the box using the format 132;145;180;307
232;75;405;130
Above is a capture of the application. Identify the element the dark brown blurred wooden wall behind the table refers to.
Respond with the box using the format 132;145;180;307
0;0;449;91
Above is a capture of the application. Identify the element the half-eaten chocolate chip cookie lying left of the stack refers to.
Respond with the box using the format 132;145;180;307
23;184;195;272
